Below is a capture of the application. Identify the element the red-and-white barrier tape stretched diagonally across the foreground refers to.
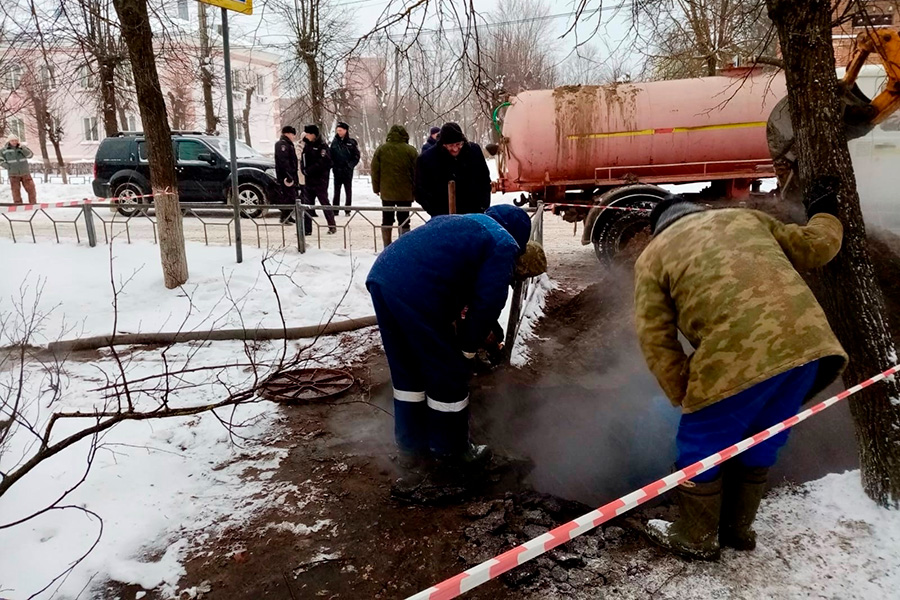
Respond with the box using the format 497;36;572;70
406;364;900;600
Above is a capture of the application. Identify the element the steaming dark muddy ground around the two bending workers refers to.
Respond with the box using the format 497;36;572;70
109;207;900;600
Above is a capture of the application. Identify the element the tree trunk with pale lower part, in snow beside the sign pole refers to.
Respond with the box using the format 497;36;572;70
113;0;188;289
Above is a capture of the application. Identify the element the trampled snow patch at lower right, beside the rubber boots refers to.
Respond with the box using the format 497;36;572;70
616;471;900;600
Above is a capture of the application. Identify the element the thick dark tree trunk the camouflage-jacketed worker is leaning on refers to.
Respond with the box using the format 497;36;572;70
766;0;900;508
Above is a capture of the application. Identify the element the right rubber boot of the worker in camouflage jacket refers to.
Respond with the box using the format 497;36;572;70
719;464;769;551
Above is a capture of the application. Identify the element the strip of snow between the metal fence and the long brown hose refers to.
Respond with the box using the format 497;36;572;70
0;239;375;345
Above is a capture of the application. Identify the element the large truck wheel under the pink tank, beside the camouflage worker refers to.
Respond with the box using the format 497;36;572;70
591;184;669;264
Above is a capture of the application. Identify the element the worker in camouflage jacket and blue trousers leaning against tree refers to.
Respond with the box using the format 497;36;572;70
635;183;847;560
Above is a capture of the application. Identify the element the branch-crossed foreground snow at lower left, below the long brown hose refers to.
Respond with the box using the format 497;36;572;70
0;329;377;598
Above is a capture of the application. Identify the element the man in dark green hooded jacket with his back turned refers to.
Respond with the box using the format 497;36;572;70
372;125;419;248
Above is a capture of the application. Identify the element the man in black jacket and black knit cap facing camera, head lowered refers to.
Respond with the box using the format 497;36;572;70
416;123;491;217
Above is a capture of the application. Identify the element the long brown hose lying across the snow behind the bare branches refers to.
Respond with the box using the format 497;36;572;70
47;316;378;353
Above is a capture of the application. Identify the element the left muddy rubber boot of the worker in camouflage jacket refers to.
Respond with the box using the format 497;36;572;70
646;477;722;560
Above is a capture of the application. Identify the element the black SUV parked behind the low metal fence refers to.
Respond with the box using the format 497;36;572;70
93;131;278;218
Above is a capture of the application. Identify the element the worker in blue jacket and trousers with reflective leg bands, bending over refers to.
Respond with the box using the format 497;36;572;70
366;205;531;496
